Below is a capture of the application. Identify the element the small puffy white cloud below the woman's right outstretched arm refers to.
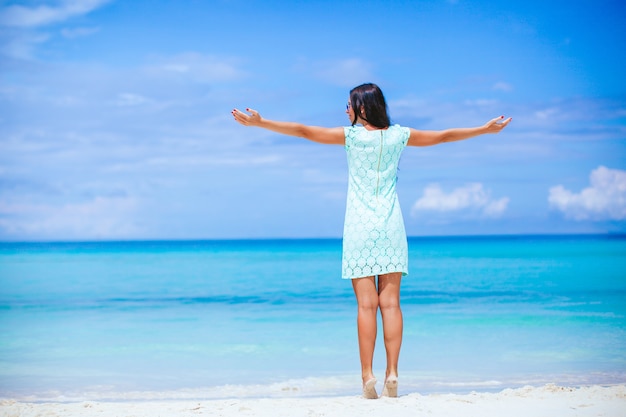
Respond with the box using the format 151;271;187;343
411;183;509;217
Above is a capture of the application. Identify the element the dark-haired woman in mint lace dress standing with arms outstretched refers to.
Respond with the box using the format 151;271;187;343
232;84;511;398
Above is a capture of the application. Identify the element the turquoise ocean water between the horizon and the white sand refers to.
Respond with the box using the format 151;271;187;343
0;236;626;400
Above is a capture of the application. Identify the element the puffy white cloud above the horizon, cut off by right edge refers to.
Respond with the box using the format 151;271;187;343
548;166;626;220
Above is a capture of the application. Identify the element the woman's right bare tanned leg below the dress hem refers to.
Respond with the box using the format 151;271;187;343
378;273;403;397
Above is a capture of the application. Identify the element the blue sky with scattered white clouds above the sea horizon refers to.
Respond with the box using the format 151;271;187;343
0;0;626;240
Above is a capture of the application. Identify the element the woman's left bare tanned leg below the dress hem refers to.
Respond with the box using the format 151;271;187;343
352;277;378;386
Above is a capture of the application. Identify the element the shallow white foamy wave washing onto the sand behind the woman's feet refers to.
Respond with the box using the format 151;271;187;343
0;372;626;403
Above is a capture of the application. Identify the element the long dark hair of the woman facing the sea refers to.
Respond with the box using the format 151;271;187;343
350;83;391;129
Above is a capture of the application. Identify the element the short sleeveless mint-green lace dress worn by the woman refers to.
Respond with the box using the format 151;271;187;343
342;125;410;279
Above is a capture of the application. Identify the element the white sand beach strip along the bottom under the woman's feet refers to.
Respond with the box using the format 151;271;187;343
0;385;626;417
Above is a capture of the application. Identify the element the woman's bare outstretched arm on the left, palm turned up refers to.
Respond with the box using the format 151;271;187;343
232;109;345;145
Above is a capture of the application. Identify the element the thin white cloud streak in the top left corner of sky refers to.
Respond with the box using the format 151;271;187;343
0;0;109;28
